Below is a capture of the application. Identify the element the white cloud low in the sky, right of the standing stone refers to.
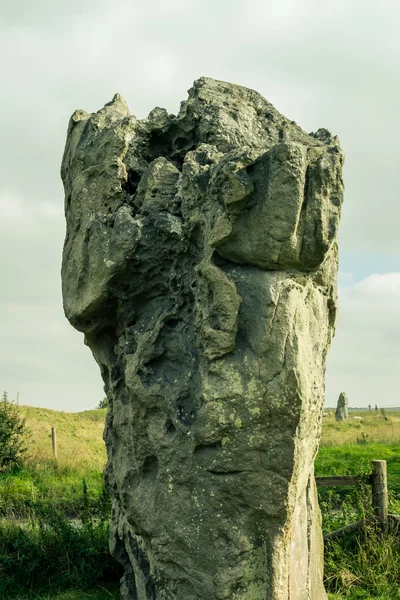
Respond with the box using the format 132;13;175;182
327;273;400;406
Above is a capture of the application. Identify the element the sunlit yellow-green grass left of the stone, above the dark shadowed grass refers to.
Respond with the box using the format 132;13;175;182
0;406;106;519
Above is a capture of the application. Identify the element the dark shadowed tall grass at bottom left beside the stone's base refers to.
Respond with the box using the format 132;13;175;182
0;480;121;599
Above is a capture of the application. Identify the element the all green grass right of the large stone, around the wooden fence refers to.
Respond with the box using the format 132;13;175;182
315;411;400;600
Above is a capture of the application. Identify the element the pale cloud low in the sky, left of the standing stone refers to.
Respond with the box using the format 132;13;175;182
0;301;104;412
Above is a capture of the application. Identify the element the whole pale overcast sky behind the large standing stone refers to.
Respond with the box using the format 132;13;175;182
0;0;400;411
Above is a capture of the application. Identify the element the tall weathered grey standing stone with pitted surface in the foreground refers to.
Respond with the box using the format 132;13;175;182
62;78;343;600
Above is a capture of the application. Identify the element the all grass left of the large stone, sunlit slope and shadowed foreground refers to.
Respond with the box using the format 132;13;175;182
0;407;122;600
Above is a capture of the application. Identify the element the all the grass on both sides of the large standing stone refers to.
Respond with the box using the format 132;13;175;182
0;407;400;600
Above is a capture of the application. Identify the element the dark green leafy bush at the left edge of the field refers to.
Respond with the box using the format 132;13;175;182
0;392;27;472
